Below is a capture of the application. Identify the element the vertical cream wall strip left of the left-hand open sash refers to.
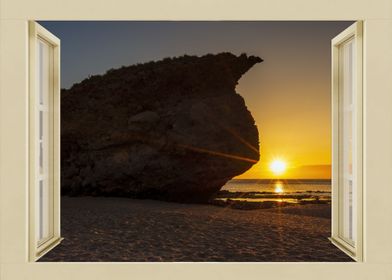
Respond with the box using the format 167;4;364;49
0;20;28;264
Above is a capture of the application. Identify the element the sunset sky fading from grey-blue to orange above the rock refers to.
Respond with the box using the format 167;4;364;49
40;21;352;179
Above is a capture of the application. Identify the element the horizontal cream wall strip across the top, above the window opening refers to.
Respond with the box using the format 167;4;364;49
1;0;392;20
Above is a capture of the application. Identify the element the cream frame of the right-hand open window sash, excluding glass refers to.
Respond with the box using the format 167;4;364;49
331;21;364;261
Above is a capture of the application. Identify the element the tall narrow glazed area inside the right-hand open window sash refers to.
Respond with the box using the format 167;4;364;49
339;37;356;245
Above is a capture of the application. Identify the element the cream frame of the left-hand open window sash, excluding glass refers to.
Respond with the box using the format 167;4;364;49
29;21;62;261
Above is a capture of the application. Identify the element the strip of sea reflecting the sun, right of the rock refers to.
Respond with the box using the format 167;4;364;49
217;179;331;203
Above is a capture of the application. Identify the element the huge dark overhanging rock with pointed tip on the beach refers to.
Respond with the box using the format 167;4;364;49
61;53;262;202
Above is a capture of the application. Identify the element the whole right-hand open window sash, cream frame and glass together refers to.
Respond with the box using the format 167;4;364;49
331;22;363;261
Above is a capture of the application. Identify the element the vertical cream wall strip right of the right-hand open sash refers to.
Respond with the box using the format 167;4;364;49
363;20;392;262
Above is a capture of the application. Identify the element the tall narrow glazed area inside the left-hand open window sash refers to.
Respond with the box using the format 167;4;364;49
36;40;51;245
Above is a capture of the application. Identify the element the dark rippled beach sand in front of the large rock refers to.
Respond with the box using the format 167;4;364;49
40;197;352;262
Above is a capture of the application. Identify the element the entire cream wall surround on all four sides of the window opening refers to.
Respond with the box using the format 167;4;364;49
0;0;392;280
